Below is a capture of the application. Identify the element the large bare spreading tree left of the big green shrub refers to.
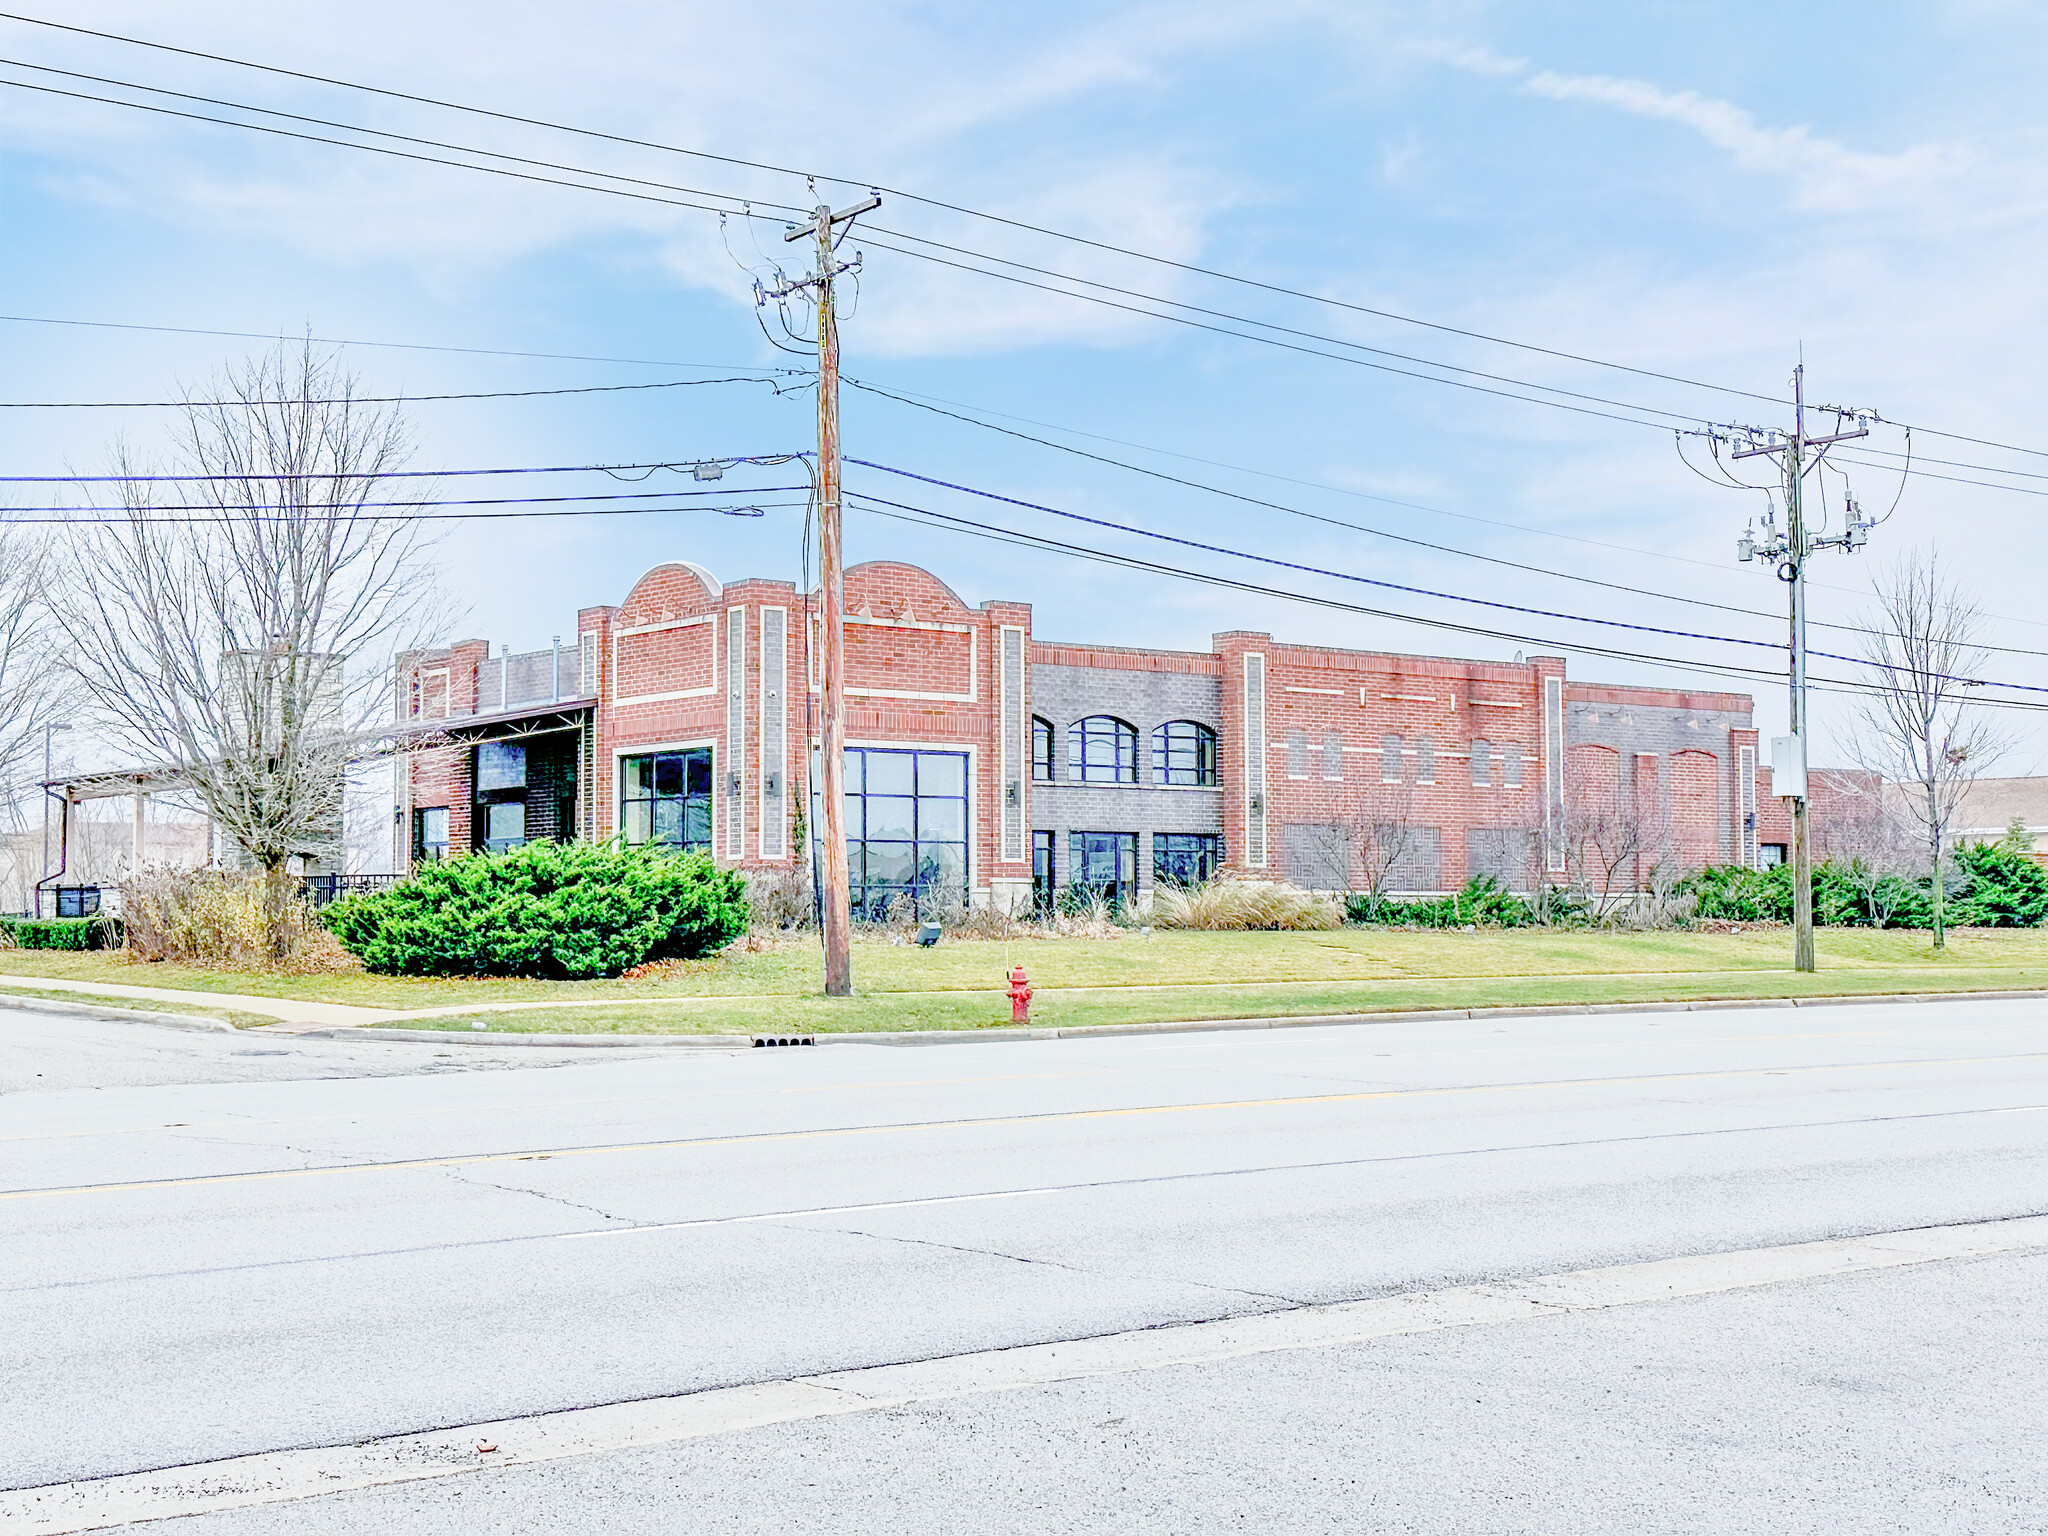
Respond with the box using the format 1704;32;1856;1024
59;342;442;950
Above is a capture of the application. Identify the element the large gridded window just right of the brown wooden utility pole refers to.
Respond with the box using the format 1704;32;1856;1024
846;748;967;920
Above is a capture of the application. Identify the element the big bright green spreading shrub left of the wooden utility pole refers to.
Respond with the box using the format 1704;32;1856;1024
326;842;748;981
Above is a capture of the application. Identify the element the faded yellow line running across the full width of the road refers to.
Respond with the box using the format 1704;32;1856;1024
0;1051;2048;1200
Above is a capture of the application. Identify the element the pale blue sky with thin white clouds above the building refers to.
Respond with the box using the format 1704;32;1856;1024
0;0;2048;772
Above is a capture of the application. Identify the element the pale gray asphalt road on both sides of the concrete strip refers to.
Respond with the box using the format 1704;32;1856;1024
0;1001;2048;1532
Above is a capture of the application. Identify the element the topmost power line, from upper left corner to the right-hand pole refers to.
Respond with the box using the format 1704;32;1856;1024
0;12;1784;406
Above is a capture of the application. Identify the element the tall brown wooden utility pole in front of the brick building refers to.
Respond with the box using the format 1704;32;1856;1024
778;197;883;997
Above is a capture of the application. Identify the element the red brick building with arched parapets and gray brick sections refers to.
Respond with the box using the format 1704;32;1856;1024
395;561;1790;911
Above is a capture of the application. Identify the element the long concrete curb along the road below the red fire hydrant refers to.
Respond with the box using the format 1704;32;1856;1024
297;989;2048;1051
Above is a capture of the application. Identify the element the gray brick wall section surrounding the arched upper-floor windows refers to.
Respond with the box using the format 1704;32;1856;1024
1030;662;1229;897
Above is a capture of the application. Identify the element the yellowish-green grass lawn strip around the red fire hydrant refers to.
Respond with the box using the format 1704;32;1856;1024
12;928;2048;1032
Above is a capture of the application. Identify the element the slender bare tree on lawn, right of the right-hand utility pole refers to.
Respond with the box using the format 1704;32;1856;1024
1855;555;2007;948
